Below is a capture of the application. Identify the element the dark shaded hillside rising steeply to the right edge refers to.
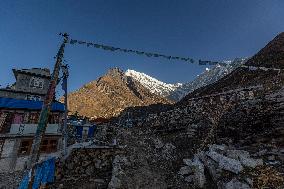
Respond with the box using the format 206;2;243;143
180;33;284;103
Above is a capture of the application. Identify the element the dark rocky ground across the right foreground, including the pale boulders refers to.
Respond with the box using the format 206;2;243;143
96;85;284;188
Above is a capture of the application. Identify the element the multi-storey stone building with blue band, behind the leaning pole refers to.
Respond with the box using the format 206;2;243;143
0;68;64;172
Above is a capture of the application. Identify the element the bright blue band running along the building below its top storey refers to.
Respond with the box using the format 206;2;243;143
0;97;64;111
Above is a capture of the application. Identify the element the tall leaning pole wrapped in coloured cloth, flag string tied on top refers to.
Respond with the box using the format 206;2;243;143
28;33;68;189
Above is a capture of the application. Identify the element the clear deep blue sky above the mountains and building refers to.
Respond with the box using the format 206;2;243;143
0;0;284;94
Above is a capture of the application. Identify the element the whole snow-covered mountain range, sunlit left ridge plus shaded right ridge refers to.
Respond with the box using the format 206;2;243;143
125;58;247;101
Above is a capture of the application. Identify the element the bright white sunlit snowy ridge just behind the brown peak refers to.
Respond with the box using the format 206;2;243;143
125;69;182;97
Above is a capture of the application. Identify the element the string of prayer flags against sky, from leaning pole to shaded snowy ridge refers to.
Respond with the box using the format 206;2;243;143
69;39;227;66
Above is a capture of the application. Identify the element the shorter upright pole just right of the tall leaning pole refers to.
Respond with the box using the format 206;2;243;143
61;64;69;156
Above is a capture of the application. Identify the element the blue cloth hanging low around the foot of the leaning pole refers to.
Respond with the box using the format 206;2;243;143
18;158;55;189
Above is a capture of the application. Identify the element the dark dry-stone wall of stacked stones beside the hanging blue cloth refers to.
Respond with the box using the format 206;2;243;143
50;147;122;188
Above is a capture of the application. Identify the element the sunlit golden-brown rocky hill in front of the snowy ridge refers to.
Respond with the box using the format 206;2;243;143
68;68;170;118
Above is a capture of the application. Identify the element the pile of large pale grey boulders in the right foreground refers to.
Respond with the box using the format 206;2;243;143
178;144;283;189
